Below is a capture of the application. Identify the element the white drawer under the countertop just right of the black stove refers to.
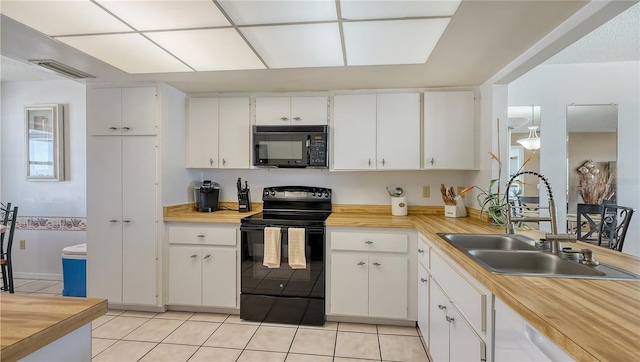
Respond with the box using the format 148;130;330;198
331;231;409;253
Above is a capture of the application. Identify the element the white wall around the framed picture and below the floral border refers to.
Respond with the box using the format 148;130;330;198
0;81;86;278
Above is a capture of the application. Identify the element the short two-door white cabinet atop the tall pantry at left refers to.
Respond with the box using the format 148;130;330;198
87;87;157;136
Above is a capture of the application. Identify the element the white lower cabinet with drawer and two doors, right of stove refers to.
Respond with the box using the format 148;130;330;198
330;232;415;320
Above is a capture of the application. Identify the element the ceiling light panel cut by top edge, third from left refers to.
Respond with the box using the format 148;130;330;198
219;0;337;25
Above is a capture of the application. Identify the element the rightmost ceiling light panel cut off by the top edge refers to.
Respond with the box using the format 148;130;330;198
340;0;460;20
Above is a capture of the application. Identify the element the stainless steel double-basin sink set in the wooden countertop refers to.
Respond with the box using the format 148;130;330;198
438;233;640;280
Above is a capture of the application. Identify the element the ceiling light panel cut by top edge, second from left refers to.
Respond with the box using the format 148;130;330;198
98;0;230;31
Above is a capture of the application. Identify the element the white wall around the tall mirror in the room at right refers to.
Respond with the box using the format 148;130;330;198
509;62;640;255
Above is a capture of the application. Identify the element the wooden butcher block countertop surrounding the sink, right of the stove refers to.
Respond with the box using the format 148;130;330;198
165;205;640;361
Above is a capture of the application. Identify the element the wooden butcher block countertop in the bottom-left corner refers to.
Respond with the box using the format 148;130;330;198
0;293;107;361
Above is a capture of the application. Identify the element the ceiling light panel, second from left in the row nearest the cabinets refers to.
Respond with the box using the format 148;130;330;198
145;29;265;71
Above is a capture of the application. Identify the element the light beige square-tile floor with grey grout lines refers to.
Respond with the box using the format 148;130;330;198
2;279;429;362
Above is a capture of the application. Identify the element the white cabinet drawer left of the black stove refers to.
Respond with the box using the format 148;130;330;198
169;226;236;246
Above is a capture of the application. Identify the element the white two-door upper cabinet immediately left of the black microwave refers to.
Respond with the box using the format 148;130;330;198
186;97;251;168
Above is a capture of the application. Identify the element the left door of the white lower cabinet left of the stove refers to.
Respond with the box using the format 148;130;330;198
169;245;202;305
